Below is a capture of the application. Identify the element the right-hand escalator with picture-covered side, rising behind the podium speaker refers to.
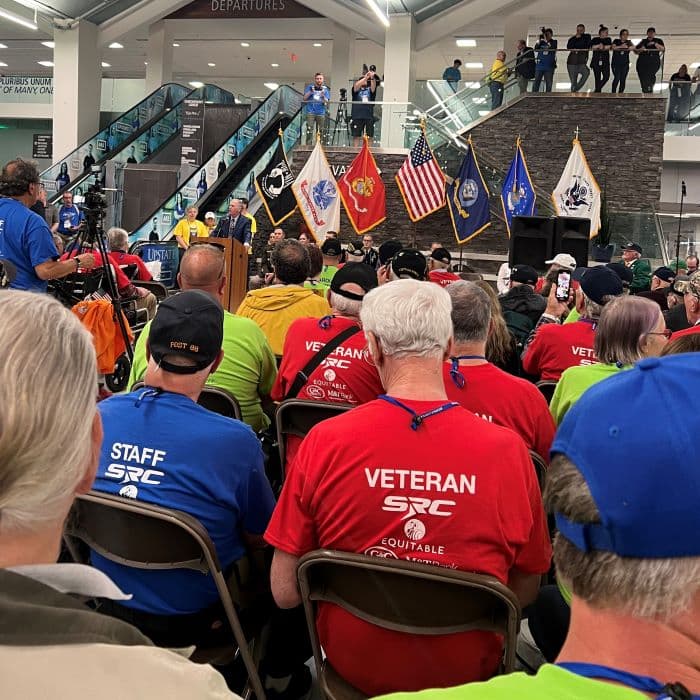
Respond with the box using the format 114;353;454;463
130;85;302;241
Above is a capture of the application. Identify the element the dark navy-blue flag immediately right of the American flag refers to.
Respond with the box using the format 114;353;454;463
447;139;491;245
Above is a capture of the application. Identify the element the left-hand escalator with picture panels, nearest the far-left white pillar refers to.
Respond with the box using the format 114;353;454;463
42;85;234;204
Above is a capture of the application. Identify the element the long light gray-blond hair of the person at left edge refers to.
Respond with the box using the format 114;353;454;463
0;291;97;534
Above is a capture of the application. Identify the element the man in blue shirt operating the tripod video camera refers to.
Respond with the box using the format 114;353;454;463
0;158;95;292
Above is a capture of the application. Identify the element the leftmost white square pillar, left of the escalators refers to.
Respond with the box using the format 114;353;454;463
53;20;102;163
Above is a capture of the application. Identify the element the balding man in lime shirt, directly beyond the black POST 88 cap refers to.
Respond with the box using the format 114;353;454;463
129;243;277;431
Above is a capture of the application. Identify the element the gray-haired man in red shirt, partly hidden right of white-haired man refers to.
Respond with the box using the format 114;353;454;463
443;281;555;459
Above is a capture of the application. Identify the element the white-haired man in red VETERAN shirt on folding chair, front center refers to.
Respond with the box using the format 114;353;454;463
265;280;550;696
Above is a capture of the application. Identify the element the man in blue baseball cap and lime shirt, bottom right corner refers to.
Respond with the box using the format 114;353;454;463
394;355;700;700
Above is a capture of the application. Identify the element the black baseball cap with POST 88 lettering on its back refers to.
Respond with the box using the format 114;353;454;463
148;290;224;374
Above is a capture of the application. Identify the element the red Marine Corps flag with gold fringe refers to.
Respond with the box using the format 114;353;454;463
338;136;386;234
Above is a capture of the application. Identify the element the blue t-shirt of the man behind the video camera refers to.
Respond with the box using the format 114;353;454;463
0;198;58;292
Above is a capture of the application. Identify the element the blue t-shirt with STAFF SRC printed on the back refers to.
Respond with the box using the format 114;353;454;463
92;388;275;615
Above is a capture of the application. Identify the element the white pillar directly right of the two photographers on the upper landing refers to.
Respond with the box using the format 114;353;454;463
378;14;416;148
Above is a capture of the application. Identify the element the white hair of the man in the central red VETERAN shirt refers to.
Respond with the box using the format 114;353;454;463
360;280;452;357
